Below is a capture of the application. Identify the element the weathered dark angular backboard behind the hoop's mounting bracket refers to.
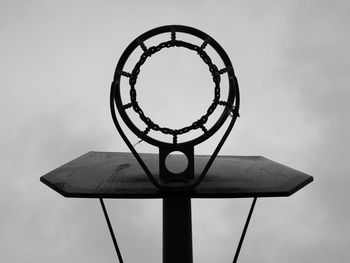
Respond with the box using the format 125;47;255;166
40;152;313;198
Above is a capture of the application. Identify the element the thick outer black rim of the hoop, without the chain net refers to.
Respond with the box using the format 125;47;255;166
111;25;239;150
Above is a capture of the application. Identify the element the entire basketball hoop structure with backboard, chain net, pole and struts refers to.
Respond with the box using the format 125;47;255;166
40;25;313;263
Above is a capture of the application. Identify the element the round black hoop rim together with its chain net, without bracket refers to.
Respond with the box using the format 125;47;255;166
113;25;239;147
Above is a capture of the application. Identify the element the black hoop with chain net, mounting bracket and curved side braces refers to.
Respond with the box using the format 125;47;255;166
110;25;240;192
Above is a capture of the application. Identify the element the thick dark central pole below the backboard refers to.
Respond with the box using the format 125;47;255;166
163;197;193;263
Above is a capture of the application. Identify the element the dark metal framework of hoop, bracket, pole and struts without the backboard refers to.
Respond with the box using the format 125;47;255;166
106;25;257;263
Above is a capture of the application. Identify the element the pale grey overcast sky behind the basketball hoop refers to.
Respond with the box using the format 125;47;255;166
0;1;350;263
